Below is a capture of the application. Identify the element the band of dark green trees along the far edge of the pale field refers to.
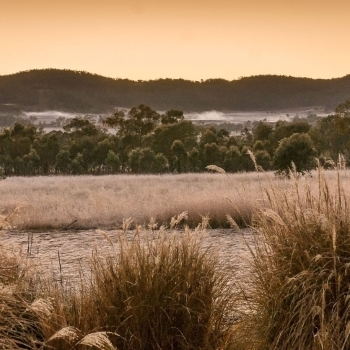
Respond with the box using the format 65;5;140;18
0;99;350;176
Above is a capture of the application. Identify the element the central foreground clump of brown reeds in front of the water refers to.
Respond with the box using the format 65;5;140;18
44;217;237;350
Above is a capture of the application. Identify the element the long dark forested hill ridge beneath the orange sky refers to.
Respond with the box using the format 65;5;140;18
0;69;350;113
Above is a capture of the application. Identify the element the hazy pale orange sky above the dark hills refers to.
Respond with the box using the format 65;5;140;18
0;0;350;80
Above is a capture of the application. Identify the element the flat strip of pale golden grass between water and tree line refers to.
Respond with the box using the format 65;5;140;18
0;173;281;229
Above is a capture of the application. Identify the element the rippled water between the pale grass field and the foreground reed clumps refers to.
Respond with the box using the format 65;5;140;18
1;229;253;283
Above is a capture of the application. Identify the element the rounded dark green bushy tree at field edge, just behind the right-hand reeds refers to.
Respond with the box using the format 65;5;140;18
273;133;317;176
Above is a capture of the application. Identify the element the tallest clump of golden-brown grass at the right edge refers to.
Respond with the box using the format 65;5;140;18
246;168;350;350
